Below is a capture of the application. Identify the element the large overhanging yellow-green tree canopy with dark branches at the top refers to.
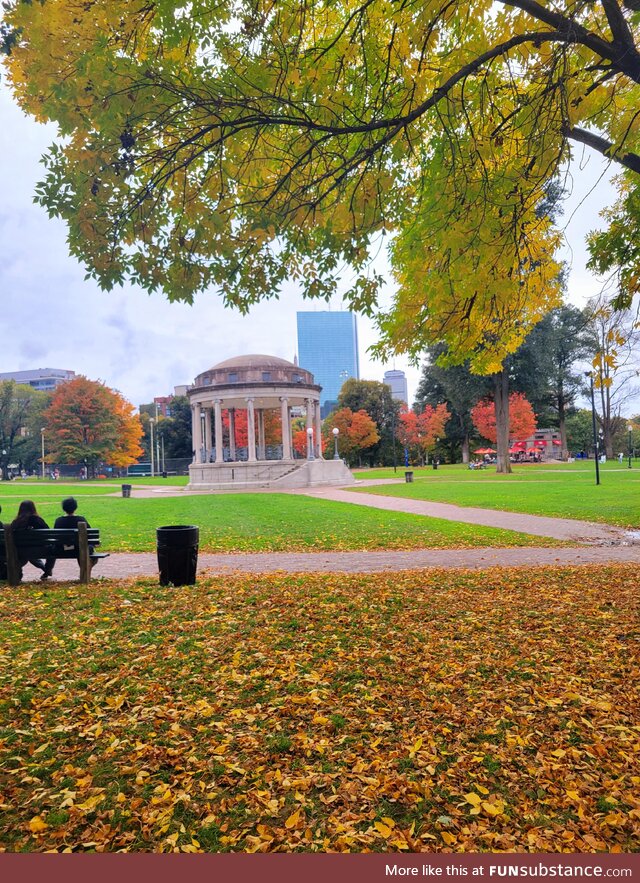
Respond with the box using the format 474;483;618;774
2;0;640;373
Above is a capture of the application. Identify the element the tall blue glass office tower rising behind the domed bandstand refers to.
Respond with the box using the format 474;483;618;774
297;310;360;417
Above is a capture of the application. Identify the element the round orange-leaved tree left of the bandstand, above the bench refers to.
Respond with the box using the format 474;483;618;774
44;377;143;473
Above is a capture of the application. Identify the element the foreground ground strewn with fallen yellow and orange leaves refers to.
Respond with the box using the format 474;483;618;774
0;567;640;852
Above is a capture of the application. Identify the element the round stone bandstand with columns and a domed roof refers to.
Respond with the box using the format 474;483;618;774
187;355;354;490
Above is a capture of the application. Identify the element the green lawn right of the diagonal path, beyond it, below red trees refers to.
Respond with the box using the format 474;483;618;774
356;460;640;527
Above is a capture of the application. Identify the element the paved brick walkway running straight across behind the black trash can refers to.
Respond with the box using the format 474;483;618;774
25;545;640;582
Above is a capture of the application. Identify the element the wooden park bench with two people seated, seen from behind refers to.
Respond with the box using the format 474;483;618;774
0;521;109;586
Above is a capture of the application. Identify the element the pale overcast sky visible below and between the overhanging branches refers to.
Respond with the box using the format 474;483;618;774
0;85;612;405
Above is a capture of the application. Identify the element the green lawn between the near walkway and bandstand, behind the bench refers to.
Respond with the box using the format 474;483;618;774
0;482;556;552
